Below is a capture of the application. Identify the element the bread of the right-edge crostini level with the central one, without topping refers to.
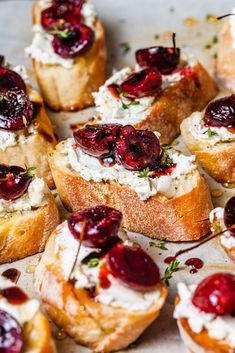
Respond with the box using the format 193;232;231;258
181;117;235;183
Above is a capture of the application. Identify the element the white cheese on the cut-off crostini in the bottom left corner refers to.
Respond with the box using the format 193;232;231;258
0;277;39;326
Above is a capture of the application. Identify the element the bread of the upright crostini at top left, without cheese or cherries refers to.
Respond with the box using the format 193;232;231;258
33;2;106;111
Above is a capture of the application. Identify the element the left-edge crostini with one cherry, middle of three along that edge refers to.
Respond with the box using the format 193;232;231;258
0;164;59;263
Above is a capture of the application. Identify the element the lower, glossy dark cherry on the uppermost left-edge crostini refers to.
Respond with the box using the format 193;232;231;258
0;90;34;131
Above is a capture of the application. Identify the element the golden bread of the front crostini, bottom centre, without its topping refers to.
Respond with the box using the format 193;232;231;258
35;231;167;352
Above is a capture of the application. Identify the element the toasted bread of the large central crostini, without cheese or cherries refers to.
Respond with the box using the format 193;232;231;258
49;142;212;241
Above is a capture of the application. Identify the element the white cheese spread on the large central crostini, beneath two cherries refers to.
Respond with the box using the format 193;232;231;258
62;139;196;200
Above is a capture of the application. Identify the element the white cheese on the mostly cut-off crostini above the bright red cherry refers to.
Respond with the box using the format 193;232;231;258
210;207;235;249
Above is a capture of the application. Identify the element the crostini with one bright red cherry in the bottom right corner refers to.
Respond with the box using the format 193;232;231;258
174;273;235;353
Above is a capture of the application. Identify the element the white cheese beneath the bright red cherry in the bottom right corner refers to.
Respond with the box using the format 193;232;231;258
174;283;235;348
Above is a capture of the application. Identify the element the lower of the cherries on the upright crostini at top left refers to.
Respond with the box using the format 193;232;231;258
52;23;95;58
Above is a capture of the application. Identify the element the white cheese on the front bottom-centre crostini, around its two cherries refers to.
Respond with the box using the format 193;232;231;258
55;221;163;311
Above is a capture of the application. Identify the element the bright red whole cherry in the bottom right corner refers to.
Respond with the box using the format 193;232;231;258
192;273;235;315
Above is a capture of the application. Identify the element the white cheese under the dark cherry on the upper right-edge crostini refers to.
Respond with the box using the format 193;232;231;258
189;112;235;146
